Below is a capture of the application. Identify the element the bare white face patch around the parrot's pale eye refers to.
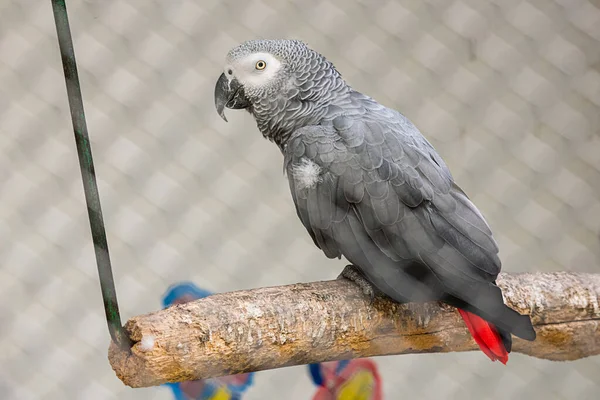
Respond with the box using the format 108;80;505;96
225;53;281;88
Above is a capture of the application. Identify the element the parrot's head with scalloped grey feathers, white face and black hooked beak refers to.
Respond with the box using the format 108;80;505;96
215;40;346;140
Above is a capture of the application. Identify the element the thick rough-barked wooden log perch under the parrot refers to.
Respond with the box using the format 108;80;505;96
109;272;600;387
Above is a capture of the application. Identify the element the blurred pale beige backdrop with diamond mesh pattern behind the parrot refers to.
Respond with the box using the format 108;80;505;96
0;0;600;400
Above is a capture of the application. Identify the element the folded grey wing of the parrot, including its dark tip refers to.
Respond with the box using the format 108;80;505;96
283;106;528;336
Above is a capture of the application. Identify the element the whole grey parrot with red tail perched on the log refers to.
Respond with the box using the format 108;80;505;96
215;40;536;364
